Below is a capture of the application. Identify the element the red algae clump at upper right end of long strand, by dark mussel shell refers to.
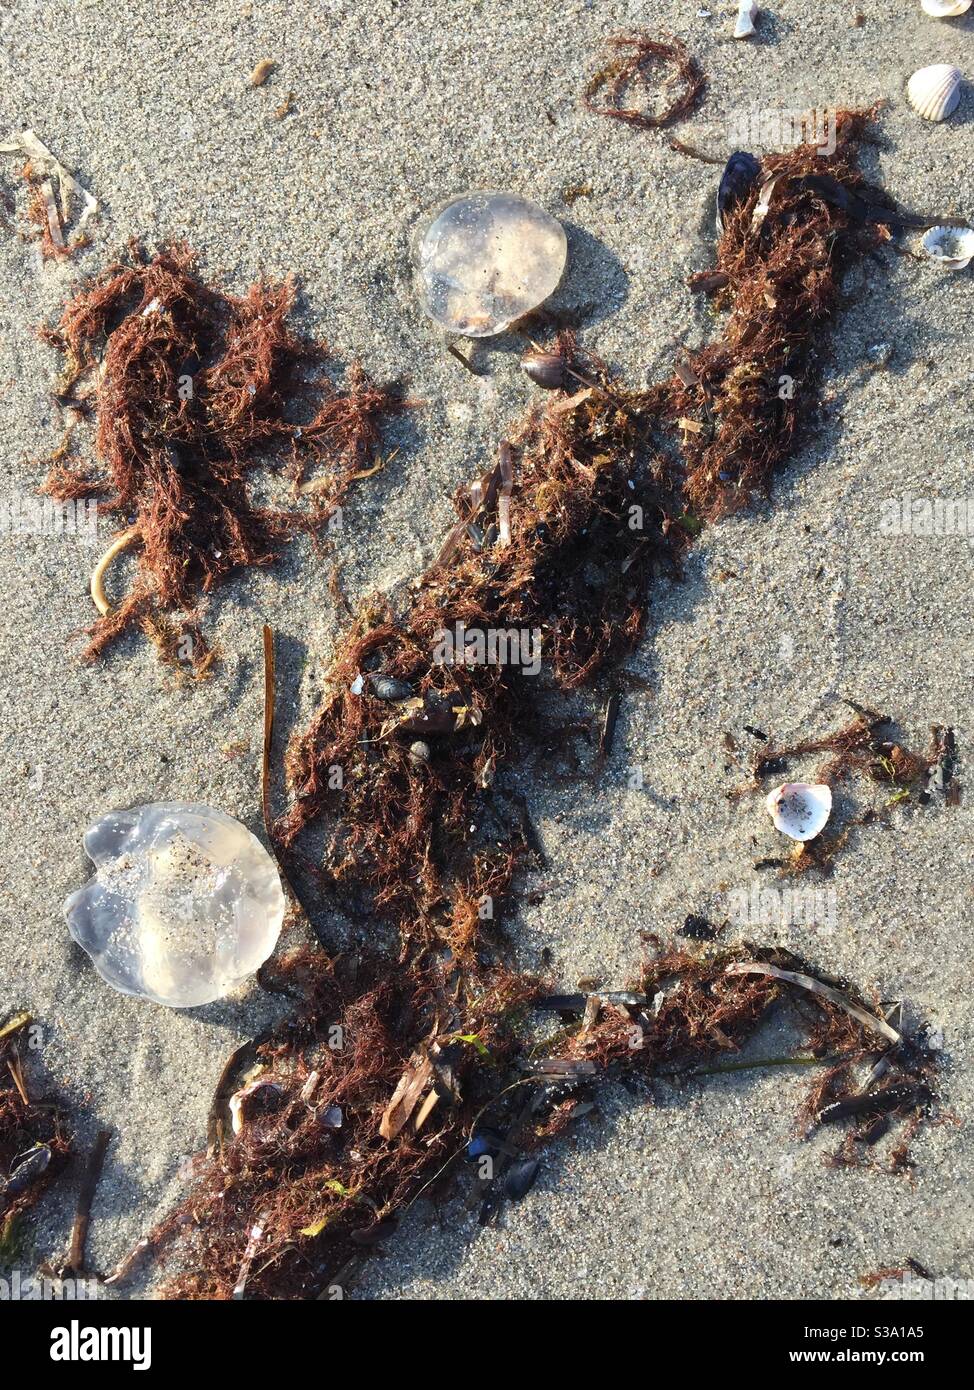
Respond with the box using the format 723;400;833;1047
650;111;889;521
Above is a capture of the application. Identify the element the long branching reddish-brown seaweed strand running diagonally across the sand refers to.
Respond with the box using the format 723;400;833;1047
108;115;934;1298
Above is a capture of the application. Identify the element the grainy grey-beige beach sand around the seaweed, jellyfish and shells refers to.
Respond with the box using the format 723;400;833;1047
0;0;974;1300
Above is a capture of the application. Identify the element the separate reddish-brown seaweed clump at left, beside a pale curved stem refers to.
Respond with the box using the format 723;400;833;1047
43;245;407;676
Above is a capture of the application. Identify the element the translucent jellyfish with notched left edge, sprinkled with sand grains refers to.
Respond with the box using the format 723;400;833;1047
64;802;285;1009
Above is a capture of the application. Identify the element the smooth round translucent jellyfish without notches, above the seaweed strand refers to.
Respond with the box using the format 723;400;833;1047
415;193;568;338
